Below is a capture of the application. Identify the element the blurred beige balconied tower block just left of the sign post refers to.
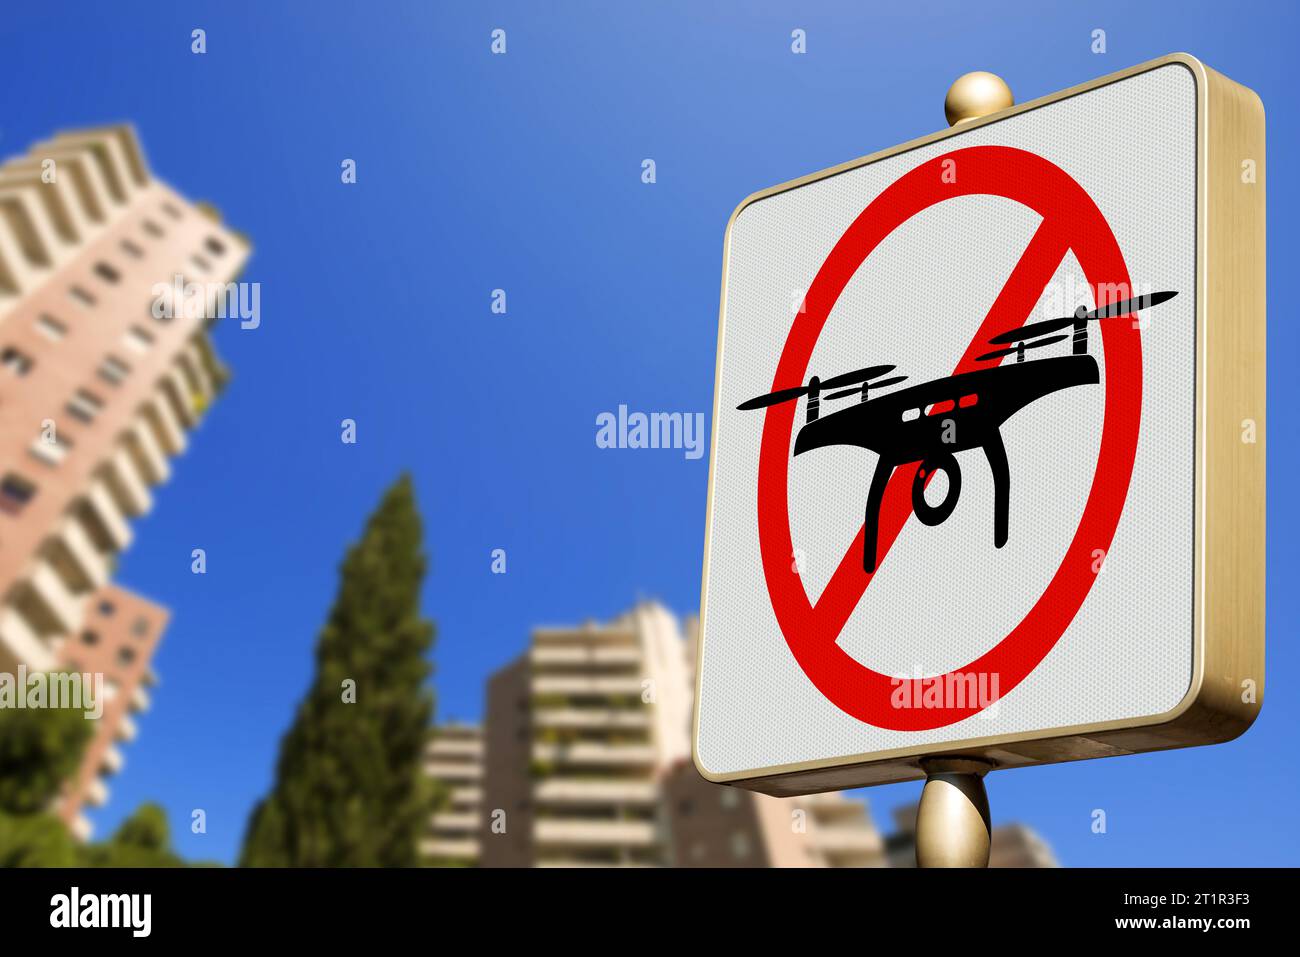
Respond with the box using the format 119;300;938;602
482;605;690;867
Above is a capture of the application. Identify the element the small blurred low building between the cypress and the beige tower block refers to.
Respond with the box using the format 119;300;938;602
420;723;484;866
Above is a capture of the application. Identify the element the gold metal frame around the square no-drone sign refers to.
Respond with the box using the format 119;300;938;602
692;53;1265;796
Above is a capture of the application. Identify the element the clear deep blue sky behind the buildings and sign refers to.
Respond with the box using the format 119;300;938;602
0;0;1300;866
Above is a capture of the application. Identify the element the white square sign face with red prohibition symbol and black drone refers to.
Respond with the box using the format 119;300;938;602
696;64;1197;780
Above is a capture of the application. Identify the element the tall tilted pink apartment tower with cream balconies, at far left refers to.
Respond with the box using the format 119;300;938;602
0;126;248;836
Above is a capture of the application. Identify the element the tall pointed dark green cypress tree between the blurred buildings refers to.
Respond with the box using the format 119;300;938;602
239;476;433;867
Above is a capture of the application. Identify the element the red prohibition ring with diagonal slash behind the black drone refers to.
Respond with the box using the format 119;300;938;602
758;146;1141;731
